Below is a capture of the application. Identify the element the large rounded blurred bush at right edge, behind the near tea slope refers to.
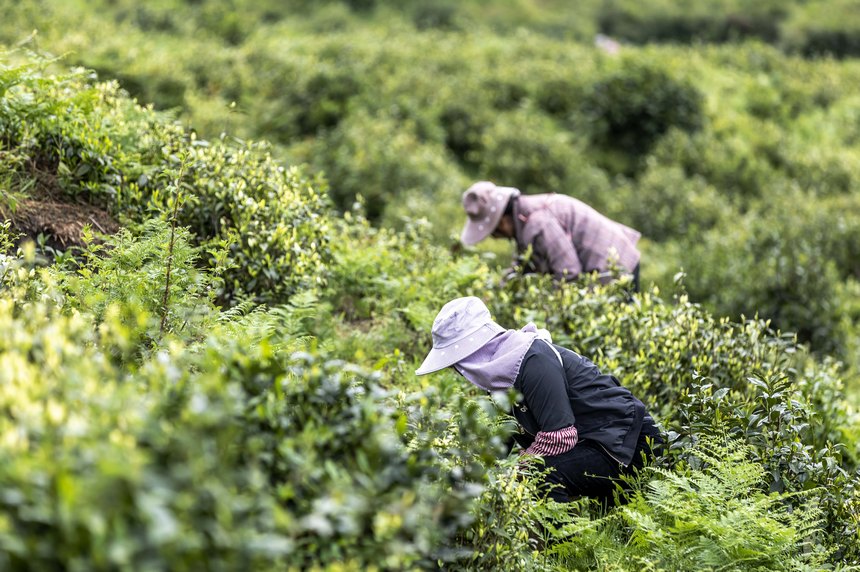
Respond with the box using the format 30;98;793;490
668;194;856;358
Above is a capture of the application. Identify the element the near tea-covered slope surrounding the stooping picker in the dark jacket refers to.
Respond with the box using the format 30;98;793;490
0;54;860;570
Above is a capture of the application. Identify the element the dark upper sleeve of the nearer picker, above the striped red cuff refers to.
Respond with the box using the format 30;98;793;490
516;342;576;431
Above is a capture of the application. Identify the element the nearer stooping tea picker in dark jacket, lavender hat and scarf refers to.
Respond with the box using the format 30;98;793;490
415;296;662;502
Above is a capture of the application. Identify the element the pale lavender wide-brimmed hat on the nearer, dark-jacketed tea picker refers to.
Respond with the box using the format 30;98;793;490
415;296;505;375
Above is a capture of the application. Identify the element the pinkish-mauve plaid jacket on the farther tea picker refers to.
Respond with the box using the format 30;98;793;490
513;194;642;278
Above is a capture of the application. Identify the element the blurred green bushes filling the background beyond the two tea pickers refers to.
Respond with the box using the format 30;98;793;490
0;0;860;367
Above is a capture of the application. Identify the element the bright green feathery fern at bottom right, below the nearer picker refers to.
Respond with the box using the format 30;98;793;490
552;439;828;570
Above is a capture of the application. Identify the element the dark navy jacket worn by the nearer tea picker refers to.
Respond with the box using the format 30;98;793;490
514;340;646;465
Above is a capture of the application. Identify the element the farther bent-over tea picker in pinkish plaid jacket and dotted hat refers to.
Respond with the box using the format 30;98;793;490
460;181;641;291
